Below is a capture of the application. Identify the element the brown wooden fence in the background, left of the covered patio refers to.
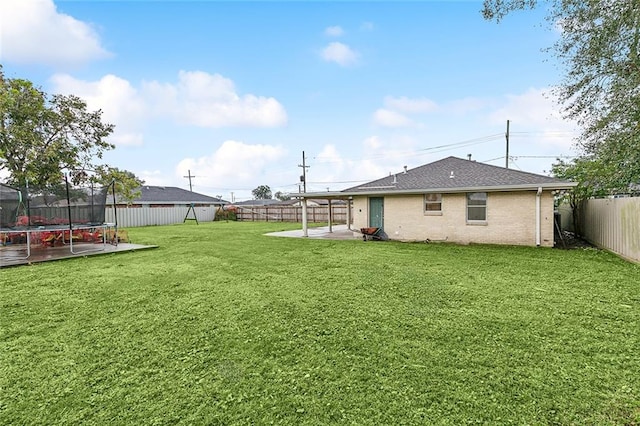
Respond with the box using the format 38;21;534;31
236;205;347;223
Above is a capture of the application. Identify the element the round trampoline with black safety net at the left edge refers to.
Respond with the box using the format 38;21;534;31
0;175;118;262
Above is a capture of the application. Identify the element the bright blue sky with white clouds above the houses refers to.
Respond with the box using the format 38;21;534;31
0;0;576;200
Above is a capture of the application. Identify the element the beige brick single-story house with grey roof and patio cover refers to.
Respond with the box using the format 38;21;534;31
292;157;576;247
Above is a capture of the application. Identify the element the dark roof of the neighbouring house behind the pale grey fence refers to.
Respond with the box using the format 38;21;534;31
115;185;228;207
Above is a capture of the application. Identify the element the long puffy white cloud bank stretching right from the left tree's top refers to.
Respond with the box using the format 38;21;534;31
51;71;287;145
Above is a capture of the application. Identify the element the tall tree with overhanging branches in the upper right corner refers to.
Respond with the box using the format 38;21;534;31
483;0;640;186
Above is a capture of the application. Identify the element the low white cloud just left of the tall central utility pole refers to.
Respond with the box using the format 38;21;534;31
176;140;286;191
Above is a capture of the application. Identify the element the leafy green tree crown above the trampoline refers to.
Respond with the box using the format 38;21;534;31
0;66;114;187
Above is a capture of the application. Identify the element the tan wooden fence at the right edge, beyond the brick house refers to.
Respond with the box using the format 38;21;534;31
582;197;640;262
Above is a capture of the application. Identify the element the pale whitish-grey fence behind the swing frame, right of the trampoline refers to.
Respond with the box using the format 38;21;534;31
105;206;217;228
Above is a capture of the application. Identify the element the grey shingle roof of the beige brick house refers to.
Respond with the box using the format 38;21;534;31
342;157;574;192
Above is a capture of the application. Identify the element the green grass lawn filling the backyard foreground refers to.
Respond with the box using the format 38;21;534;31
0;222;640;425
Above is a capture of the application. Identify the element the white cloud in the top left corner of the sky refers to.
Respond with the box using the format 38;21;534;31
0;0;110;66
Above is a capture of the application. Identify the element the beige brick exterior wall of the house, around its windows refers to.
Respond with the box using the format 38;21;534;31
353;191;554;247
